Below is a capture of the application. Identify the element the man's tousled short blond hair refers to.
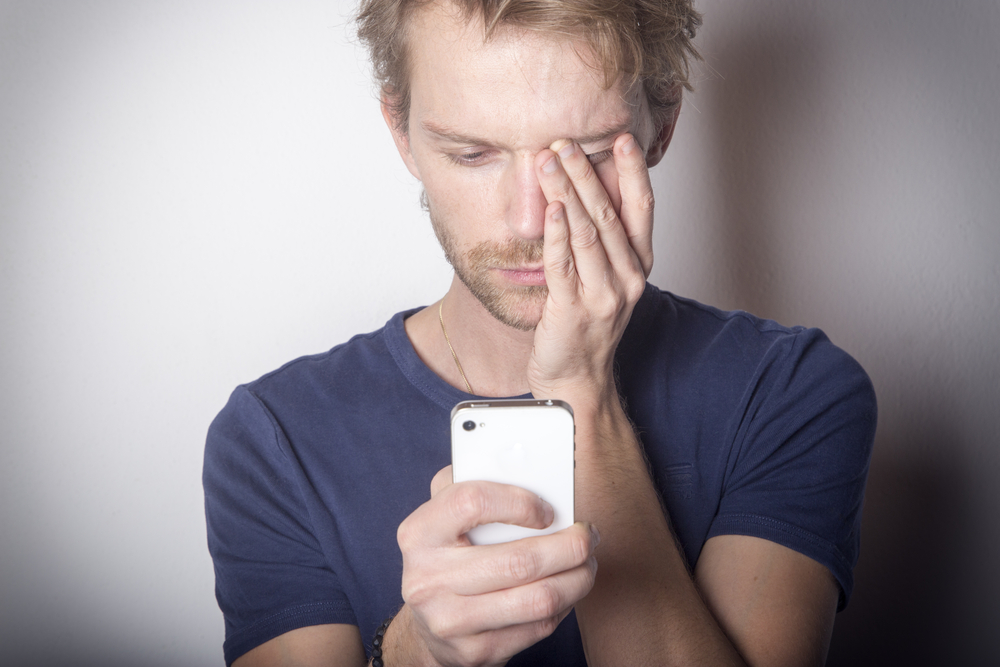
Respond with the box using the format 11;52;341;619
357;0;701;131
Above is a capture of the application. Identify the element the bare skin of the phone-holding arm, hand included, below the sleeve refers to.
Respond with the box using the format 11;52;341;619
233;474;597;667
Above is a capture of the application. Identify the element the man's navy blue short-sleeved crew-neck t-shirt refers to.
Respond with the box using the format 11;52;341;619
204;285;875;667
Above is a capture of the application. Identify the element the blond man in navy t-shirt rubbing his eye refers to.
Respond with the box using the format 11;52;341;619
205;0;874;667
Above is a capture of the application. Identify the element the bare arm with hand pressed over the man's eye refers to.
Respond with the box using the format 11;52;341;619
529;135;836;666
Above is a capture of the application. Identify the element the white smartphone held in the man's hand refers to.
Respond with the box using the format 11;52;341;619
451;399;576;544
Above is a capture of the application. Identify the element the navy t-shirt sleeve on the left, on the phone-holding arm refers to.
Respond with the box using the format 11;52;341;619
203;386;357;665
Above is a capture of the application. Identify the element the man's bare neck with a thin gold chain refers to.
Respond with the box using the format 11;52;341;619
406;277;535;396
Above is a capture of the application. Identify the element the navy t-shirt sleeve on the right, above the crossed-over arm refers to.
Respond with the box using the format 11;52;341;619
708;329;876;609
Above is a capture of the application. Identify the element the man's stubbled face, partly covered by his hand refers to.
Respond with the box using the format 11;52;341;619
387;3;654;330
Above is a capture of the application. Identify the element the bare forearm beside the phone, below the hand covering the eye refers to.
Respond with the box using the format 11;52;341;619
576;396;744;667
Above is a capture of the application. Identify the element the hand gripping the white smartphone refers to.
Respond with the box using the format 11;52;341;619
398;480;599;664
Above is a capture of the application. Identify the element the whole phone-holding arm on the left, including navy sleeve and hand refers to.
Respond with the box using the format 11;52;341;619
205;389;597;667
